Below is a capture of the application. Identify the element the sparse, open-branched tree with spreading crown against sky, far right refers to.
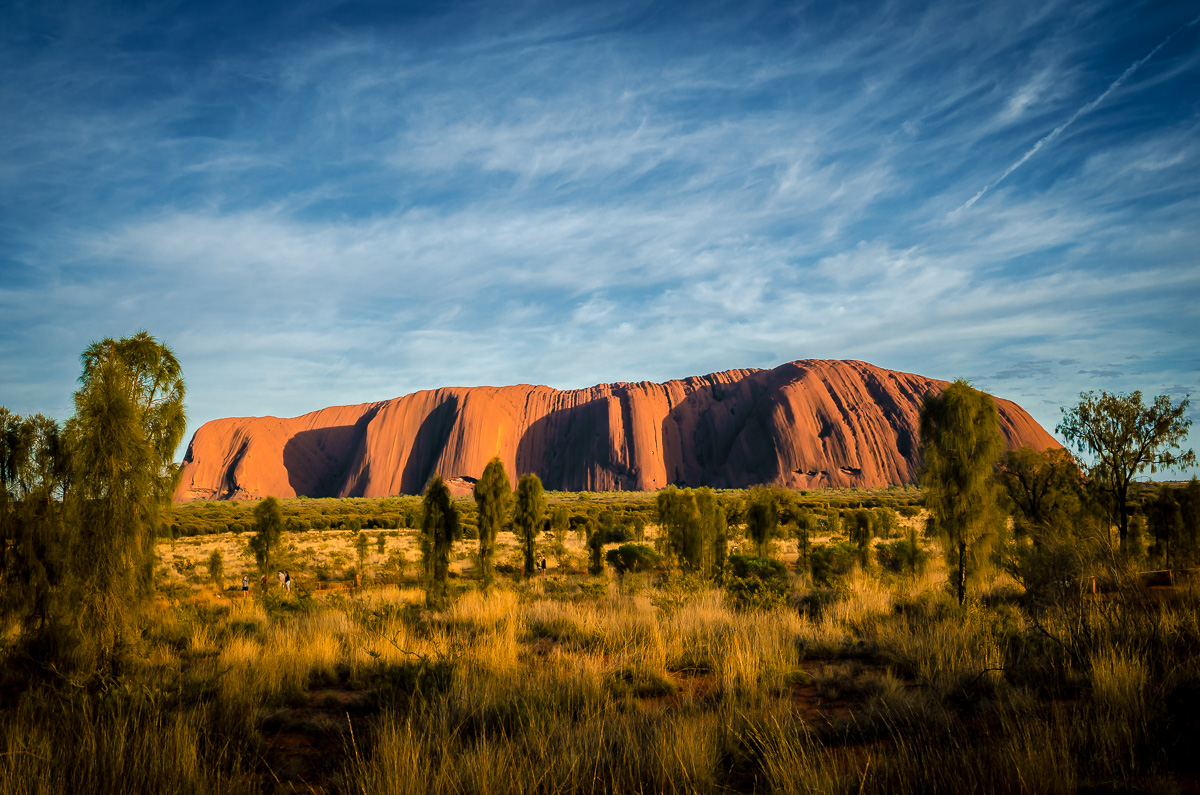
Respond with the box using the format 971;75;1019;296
1055;391;1196;552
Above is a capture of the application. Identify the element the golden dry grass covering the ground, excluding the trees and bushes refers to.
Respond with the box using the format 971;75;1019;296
0;504;1200;793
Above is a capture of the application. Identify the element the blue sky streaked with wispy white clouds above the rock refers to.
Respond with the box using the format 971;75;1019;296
0;0;1200;475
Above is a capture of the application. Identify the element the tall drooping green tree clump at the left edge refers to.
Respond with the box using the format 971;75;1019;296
0;331;187;679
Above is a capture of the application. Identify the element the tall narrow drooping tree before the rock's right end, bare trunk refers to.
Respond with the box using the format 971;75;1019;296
920;378;1003;604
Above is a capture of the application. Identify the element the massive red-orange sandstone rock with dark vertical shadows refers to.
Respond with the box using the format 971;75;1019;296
175;360;1060;501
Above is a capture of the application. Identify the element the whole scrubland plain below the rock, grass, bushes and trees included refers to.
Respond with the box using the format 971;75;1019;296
0;333;1200;794
